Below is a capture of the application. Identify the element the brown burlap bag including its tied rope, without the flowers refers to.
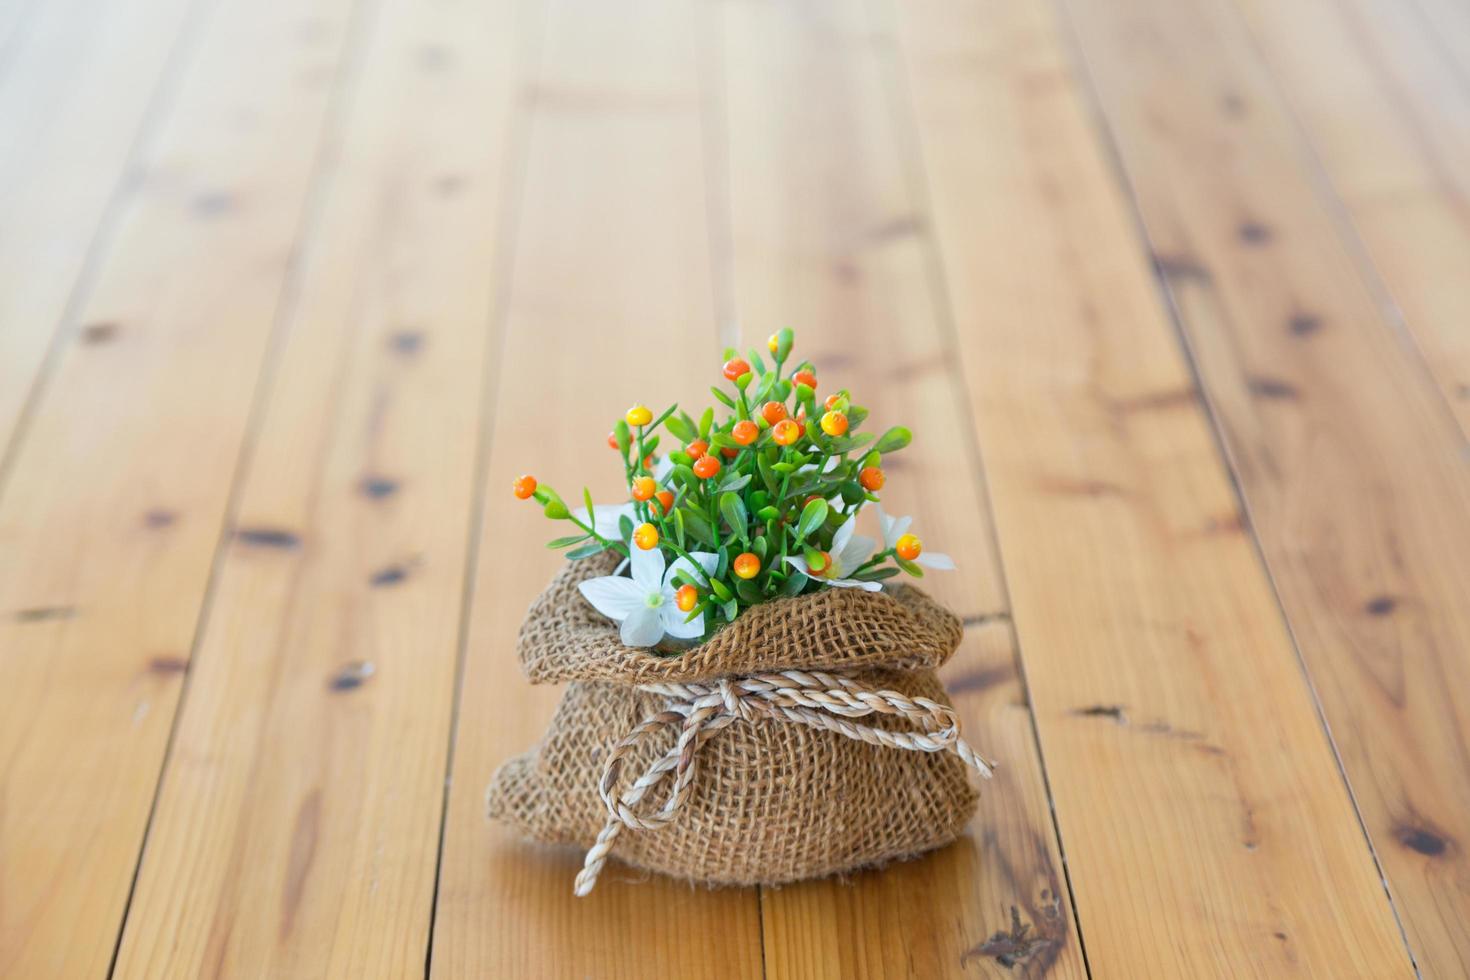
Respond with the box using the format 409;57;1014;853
488;557;989;895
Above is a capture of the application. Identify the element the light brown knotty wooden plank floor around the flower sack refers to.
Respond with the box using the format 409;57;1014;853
0;0;1470;980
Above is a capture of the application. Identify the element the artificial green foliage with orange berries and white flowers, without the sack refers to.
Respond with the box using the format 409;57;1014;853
513;329;954;646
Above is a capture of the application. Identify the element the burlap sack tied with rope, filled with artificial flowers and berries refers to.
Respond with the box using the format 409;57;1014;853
487;331;991;895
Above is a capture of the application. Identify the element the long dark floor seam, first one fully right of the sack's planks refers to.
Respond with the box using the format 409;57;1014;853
1051;0;1421;976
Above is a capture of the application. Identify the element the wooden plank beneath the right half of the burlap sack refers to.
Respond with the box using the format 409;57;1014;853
709;1;1085;977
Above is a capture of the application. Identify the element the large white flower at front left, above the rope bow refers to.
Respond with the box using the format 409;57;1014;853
578;540;720;646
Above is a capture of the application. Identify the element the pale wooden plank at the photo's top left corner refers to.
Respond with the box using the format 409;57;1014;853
0;0;194;455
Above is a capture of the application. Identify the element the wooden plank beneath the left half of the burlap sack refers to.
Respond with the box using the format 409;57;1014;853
432;0;761;977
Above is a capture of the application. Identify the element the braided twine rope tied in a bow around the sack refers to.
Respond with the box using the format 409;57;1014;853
575;670;991;896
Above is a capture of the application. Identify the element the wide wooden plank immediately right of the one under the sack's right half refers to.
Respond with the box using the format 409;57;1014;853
900;0;1411;977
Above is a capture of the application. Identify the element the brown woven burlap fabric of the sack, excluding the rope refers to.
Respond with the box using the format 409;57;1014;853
488;558;976;884
